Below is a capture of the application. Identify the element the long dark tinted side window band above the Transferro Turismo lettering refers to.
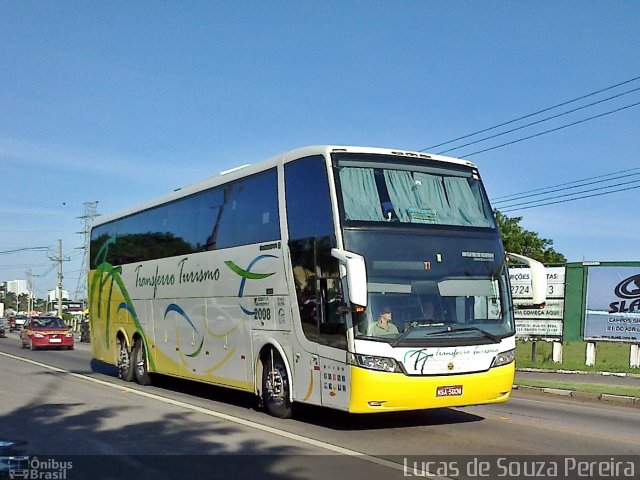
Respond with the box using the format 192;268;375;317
90;168;280;268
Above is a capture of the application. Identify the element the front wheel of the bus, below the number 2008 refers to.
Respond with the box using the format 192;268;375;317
262;349;292;418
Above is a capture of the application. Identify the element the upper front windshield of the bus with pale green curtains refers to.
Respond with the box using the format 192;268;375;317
337;154;495;228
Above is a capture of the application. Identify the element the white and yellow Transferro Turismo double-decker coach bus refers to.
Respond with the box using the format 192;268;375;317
88;146;546;417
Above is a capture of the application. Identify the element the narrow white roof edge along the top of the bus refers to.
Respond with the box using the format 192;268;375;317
92;145;476;228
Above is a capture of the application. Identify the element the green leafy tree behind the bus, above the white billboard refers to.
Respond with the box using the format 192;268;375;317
495;210;567;264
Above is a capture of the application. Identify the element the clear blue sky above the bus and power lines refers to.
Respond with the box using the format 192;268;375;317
0;0;640;297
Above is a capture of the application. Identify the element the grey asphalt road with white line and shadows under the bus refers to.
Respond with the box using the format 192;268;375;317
0;335;640;480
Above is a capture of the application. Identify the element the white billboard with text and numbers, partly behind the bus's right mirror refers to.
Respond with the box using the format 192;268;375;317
509;267;565;339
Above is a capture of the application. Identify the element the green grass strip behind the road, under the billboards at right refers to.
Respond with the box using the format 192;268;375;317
516;340;640;374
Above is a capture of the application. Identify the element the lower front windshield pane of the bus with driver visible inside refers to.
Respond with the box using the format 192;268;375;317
344;228;515;345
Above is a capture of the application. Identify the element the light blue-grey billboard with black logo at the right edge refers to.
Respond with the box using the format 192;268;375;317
584;266;640;343
